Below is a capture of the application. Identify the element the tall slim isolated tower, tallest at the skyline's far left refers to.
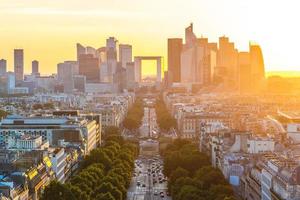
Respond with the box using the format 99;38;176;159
14;49;24;83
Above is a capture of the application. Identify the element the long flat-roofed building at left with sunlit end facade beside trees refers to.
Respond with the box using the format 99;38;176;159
0;116;101;154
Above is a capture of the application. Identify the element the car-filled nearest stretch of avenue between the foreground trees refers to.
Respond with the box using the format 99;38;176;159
127;156;171;200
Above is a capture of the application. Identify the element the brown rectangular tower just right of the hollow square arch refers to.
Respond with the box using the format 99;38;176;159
168;38;182;82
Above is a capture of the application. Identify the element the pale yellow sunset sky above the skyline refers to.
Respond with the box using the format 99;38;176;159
0;0;300;74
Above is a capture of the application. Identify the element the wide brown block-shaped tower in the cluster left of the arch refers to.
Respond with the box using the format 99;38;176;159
79;54;100;83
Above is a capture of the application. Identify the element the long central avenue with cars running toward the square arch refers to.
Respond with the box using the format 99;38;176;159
127;100;171;200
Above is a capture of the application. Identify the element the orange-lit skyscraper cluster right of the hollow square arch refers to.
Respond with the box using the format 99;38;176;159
167;24;265;93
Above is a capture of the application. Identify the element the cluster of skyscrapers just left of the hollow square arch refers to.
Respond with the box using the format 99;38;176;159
57;37;135;93
